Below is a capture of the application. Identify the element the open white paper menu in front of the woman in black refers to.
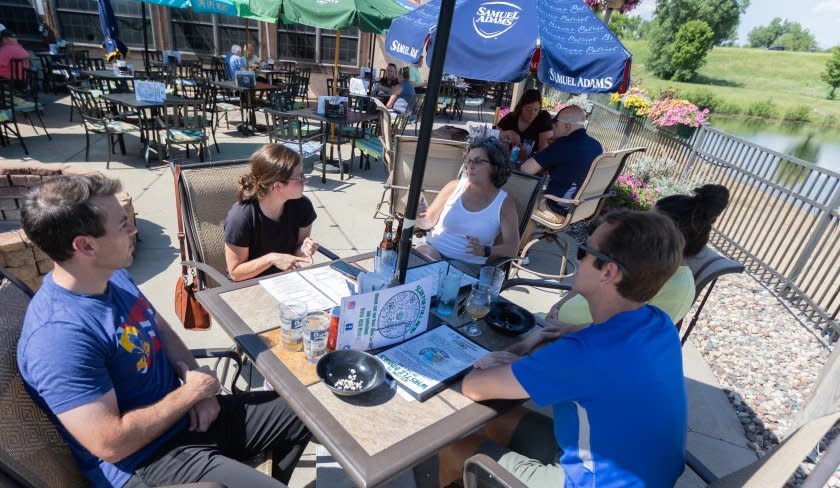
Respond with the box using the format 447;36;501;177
260;266;354;311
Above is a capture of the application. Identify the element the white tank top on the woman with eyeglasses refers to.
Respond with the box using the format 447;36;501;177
426;178;507;264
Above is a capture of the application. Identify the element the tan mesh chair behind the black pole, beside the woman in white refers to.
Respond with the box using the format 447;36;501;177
373;132;469;218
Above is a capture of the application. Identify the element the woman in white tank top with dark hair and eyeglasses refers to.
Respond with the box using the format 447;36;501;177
416;137;519;265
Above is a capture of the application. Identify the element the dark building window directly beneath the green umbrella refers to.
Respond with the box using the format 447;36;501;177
277;24;359;66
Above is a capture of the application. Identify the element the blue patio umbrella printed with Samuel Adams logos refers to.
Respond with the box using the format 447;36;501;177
386;0;632;93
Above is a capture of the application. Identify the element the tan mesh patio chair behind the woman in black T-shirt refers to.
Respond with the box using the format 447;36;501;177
171;160;339;288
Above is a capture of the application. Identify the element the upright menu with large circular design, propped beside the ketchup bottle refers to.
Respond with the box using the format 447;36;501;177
336;276;437;351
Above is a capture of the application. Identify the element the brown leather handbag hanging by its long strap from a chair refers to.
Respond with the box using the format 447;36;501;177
174;165;210;329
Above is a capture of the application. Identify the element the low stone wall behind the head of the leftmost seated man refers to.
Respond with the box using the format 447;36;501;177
0;163;136;290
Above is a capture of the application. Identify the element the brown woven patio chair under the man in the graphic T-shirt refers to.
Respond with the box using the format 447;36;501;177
0;268;239;488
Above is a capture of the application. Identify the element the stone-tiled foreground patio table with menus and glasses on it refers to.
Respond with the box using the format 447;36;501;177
198;253;521;487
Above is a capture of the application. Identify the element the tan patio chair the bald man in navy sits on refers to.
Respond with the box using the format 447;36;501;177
513;147;645;280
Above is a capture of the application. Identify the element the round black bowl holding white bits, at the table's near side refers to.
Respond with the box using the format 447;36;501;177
315;350;385;396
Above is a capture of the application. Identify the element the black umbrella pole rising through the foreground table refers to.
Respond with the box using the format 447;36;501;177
397;0;455;283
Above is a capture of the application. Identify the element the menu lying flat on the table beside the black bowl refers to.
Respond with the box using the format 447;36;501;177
377;325;489;401
